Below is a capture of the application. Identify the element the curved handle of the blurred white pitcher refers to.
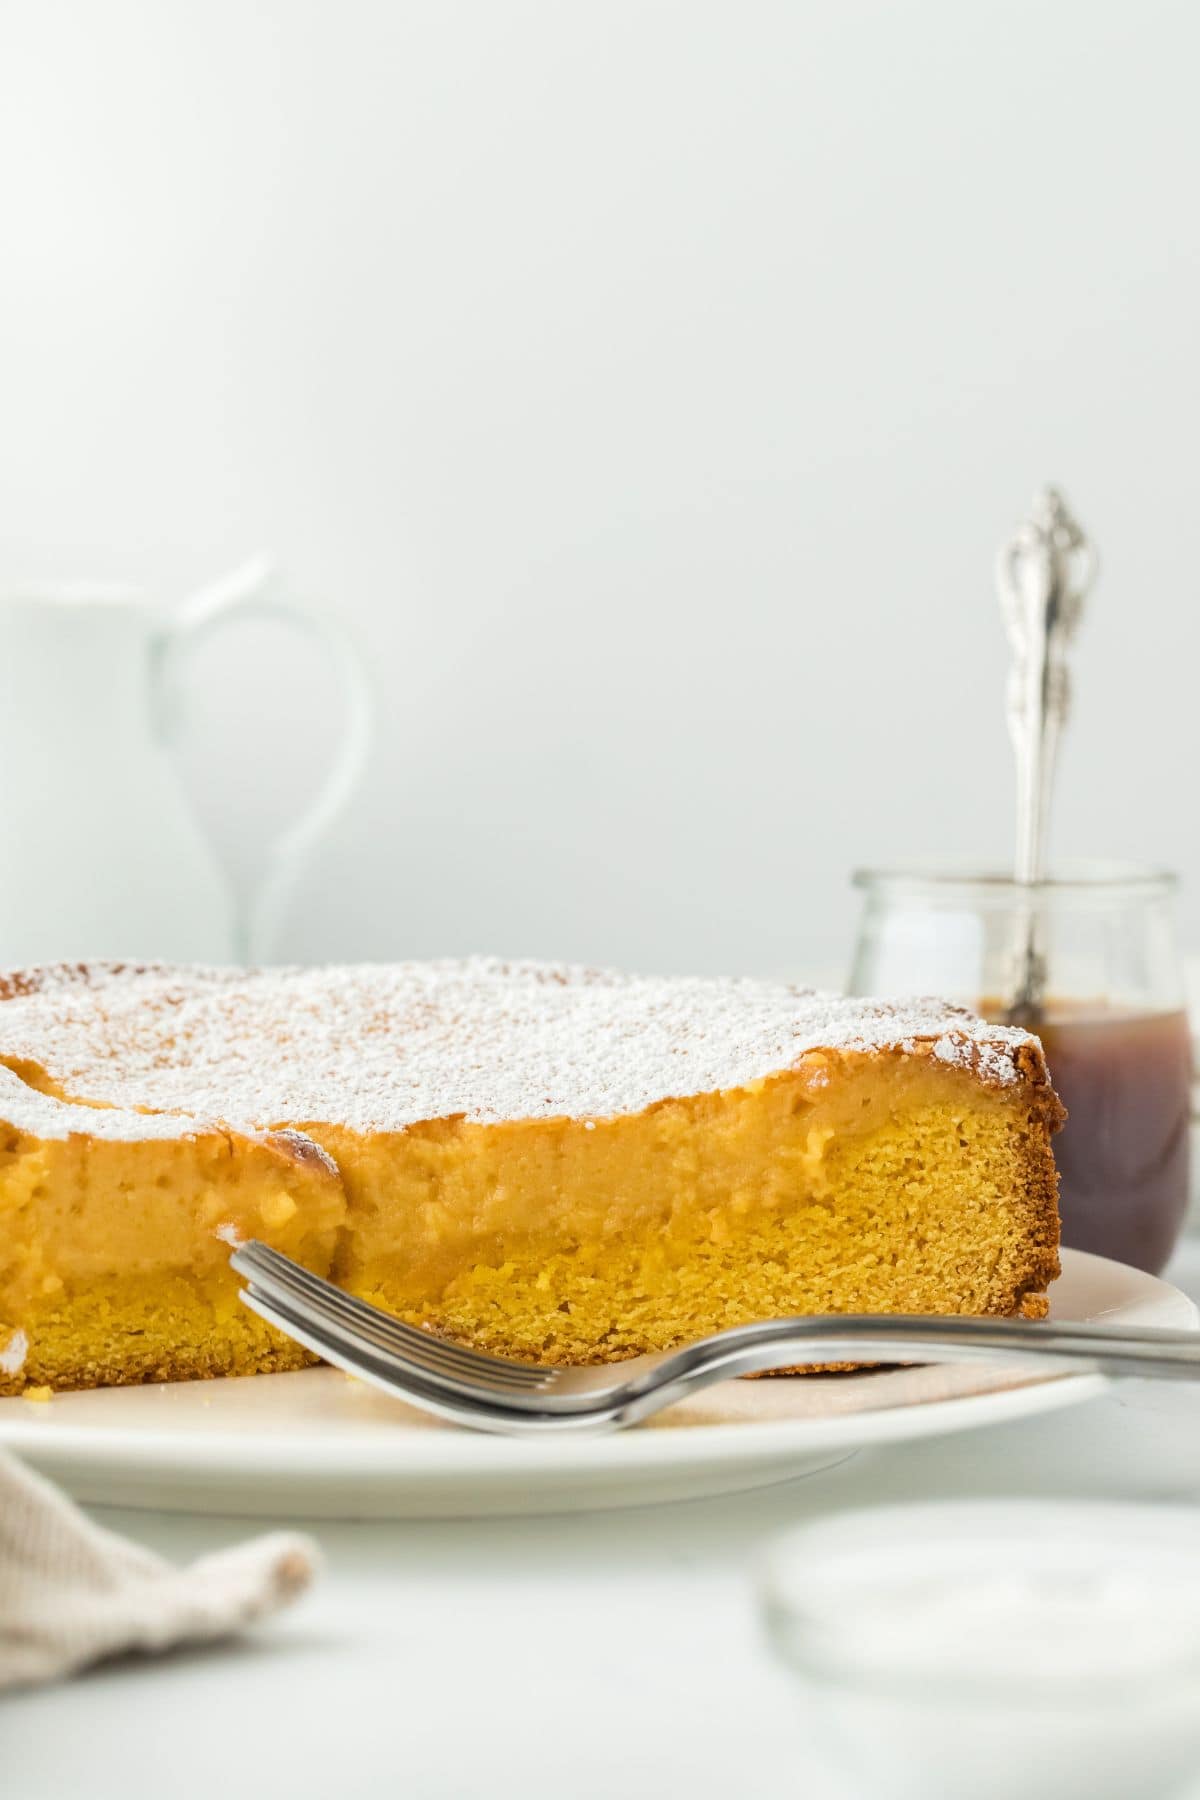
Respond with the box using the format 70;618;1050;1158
155;556;372;963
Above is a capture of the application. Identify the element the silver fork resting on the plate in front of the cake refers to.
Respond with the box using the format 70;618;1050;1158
230;1240;1200;1436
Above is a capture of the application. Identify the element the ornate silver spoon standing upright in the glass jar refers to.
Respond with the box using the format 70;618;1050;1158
997;488;1097;1022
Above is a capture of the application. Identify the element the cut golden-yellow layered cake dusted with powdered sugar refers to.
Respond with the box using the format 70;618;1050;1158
0;959;1061;1391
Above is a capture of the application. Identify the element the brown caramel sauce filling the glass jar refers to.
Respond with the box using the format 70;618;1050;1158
981;999;1191;1274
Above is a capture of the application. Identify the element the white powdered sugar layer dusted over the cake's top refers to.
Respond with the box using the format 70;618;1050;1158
0;958;1031;1138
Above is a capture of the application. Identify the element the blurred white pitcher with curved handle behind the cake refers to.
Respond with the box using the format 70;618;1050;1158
0;558;369;968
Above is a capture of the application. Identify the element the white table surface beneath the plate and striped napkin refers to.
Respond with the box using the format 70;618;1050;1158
0;1238;1200;1800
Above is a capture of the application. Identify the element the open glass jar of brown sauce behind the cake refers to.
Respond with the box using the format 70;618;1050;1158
849;864;1191;1274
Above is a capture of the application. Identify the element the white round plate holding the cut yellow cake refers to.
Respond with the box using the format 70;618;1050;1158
0;1251;1200;1519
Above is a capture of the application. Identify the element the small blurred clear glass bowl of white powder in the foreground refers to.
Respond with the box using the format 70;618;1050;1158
761;1499;1200;1800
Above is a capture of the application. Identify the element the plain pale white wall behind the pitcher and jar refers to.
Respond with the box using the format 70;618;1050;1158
0;0;1200;970
